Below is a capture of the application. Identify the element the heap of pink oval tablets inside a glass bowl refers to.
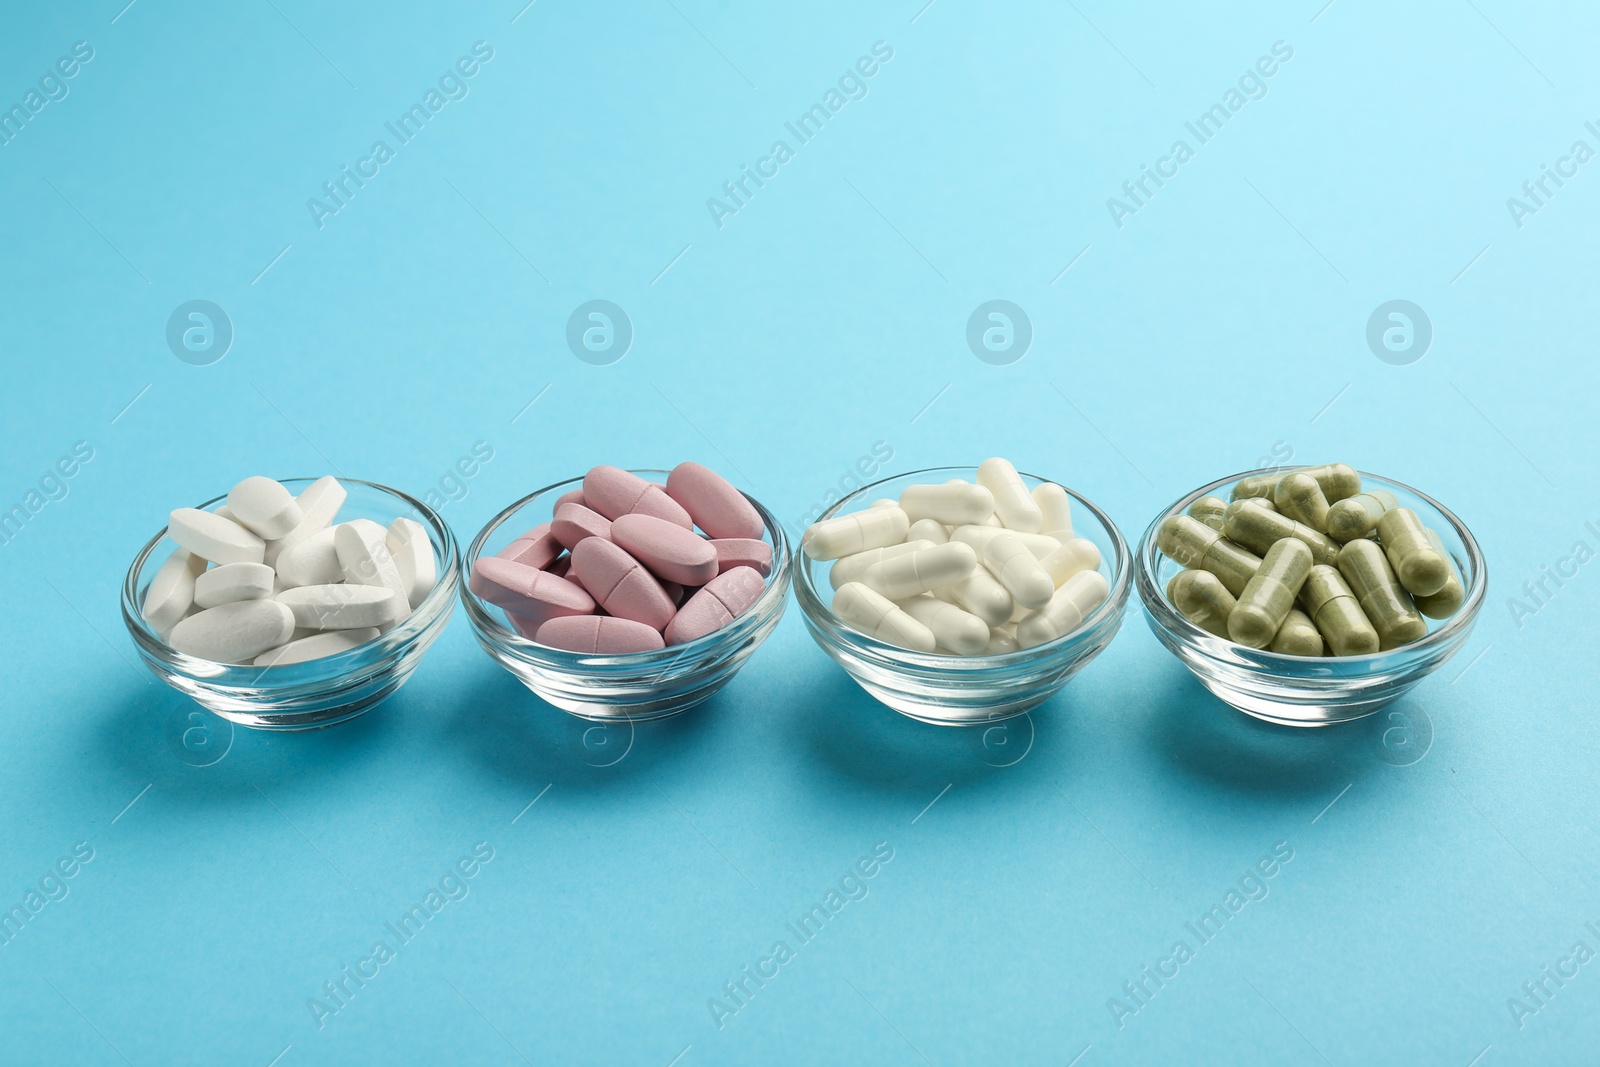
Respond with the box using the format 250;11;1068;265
467;462;773;654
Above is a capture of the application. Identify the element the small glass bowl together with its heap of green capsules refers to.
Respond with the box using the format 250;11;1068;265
1136;464;1488;726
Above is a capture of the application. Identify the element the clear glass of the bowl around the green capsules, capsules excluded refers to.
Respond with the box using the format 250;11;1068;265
1138;467;1488;726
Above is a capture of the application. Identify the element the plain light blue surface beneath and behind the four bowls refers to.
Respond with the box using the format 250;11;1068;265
0;0;1600;1067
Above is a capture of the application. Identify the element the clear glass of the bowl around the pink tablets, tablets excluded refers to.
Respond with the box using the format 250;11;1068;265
461;469;790;721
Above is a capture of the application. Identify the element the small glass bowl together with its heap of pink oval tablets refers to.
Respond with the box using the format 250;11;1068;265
461;462;790;721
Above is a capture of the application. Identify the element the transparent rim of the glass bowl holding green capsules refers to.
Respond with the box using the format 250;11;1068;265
1138;467;1488;673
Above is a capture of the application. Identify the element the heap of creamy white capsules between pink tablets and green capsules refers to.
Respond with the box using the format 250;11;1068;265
802;459;1109;656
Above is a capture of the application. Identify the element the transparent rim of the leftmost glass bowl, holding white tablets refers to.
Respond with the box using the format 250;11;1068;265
122;475;461;689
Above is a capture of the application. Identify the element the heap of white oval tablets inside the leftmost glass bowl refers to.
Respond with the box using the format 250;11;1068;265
142;477;437;667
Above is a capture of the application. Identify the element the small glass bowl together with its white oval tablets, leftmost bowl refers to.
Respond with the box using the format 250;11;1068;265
122;477;461;729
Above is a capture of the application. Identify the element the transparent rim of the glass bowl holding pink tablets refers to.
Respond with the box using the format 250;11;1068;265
459;467;792;677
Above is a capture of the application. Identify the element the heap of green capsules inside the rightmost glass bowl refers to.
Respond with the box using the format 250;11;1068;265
1157;464;1466;656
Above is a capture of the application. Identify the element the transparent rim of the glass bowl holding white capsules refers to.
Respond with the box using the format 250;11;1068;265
795;467;1133;672
